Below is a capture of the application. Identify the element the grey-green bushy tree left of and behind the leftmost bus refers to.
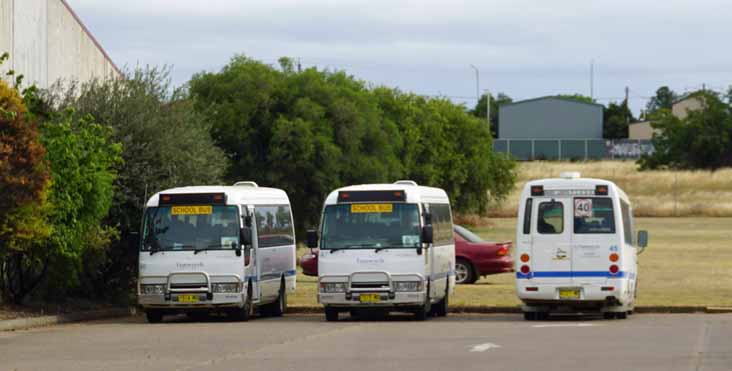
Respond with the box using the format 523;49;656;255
43;68;228;297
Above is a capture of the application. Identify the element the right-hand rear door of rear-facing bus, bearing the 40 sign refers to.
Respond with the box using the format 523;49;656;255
571;196;622;285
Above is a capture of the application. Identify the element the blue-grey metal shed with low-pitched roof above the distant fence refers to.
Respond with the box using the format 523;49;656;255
498;97;603;139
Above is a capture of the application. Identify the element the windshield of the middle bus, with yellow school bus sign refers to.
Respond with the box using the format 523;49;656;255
321;203;421;250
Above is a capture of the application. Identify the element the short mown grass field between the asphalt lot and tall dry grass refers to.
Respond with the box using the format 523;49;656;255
288;218;732;306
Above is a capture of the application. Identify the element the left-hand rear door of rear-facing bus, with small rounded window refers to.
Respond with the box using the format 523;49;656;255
529;197;572;282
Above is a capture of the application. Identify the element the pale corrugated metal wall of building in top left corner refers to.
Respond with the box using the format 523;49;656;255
0;0;120;88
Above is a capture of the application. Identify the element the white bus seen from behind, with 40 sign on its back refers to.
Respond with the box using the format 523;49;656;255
515;173;648;320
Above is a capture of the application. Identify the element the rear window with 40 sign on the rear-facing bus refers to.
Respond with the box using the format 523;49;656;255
574;197;615;234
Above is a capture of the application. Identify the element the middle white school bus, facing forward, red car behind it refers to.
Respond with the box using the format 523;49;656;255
308;181;455;321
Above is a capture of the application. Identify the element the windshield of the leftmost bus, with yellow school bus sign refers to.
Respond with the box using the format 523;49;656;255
142;205;239;251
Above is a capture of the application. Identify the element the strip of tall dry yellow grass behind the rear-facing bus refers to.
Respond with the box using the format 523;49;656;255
490;161;732;217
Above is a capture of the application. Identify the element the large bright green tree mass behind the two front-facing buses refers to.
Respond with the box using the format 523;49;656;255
190;56;514;234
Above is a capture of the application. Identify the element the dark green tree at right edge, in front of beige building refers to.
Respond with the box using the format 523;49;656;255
639;91;732;170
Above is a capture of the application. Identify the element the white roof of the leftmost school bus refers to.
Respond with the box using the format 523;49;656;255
147;182;290;207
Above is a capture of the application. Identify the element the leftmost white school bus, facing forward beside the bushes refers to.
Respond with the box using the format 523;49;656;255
137;182;296;323
